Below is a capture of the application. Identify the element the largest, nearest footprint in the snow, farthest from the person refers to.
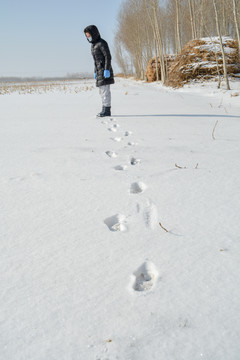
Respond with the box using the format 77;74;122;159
132;261;158;292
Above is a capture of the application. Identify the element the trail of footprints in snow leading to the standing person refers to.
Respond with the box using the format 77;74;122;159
102;117;158;292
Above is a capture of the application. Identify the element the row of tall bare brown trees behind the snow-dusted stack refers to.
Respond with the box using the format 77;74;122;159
115;0;240;83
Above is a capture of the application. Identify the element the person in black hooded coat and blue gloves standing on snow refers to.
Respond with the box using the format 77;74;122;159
84;25;114;117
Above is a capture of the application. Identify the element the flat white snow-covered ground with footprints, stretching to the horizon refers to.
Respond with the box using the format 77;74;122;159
0;79;240;360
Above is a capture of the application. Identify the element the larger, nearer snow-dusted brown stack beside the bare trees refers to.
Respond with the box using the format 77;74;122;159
168;37;240;87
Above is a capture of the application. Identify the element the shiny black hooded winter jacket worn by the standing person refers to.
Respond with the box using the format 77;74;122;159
84;25;114;86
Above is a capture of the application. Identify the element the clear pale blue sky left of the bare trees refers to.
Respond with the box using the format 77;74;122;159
0;0;123;76
